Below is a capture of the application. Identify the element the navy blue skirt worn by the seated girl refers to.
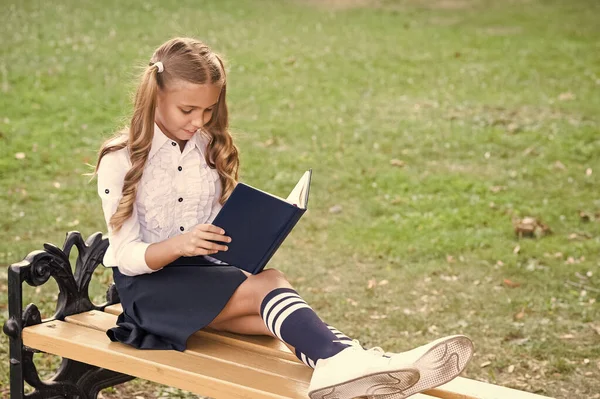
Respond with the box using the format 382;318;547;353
106;256;247;351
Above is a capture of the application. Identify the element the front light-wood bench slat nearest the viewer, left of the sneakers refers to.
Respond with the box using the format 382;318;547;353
22;321;308;399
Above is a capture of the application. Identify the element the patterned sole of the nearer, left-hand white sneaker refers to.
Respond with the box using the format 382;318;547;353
308;368;419;399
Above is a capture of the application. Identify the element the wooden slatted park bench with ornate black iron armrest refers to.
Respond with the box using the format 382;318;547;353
4;232;556;399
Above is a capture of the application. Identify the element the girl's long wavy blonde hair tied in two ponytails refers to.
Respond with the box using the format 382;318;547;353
94;38;239;231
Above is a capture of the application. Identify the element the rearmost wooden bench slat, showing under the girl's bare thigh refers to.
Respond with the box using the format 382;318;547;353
104;303;299;362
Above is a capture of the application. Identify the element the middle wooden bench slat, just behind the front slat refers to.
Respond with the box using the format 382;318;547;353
65;311;312;384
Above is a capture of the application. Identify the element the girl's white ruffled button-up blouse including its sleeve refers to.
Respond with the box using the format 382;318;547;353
98;124;221;276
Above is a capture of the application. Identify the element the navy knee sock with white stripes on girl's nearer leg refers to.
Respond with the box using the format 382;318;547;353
260;288;349;367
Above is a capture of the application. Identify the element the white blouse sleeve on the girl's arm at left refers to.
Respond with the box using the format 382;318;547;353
98;150;160;276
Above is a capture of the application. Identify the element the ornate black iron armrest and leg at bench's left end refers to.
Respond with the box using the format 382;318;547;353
3;232;135;399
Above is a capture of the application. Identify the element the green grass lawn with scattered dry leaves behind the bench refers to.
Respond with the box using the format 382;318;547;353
0;0;600;398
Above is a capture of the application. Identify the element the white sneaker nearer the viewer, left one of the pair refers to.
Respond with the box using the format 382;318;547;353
308;340;419;399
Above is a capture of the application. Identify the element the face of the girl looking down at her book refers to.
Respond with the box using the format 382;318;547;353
155;80;221;148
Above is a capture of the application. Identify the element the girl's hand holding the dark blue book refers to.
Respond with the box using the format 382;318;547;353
179;224;231;256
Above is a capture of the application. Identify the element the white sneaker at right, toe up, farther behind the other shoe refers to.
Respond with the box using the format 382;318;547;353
370;335;473;399
